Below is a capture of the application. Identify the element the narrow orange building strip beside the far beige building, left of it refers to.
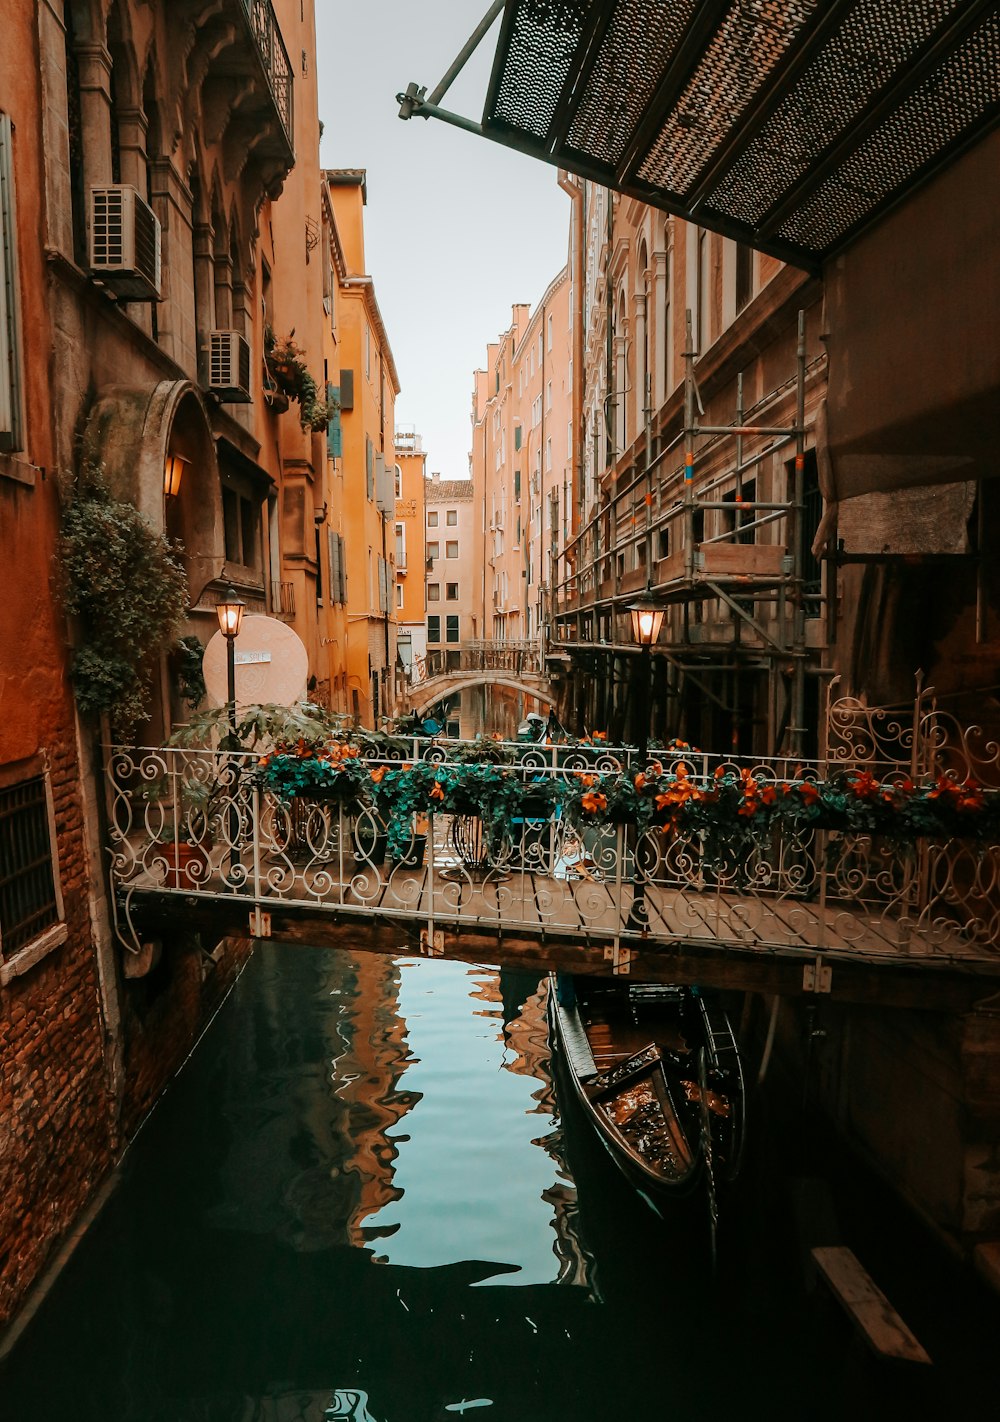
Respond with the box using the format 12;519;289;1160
394;429;427;681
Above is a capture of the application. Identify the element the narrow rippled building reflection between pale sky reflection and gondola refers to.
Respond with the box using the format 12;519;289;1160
471;970;593;1288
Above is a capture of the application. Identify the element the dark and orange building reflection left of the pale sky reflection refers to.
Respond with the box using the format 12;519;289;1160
221;947;420;1251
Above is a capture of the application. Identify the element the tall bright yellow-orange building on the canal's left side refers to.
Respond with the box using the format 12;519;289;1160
332;168;400;728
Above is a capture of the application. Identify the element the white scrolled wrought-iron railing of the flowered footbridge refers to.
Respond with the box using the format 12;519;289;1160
108;693;1000;961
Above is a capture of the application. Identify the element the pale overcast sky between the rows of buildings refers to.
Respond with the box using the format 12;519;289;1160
316;0;570;478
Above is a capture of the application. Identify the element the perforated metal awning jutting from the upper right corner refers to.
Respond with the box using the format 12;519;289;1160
400;0;1000;267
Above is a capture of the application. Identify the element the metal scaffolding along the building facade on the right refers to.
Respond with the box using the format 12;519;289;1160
550;311;826;755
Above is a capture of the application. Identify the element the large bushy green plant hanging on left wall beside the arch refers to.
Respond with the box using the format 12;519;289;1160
58;447;188;735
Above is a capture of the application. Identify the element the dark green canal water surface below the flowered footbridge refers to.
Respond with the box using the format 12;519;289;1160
0;946;999;1422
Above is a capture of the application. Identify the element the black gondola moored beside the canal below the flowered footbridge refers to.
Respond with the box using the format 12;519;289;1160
549;974;745;1217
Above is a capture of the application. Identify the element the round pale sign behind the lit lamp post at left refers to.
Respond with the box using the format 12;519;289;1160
202;616;309;707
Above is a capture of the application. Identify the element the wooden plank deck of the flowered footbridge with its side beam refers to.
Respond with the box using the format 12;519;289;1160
124;853;1000;1008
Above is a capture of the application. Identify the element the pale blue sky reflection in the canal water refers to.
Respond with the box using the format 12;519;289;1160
366;961;559;1284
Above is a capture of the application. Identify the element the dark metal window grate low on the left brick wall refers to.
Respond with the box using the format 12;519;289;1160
0;775;58;954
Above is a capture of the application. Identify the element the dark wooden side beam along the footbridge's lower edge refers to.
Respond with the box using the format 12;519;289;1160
129;890;996;1012
